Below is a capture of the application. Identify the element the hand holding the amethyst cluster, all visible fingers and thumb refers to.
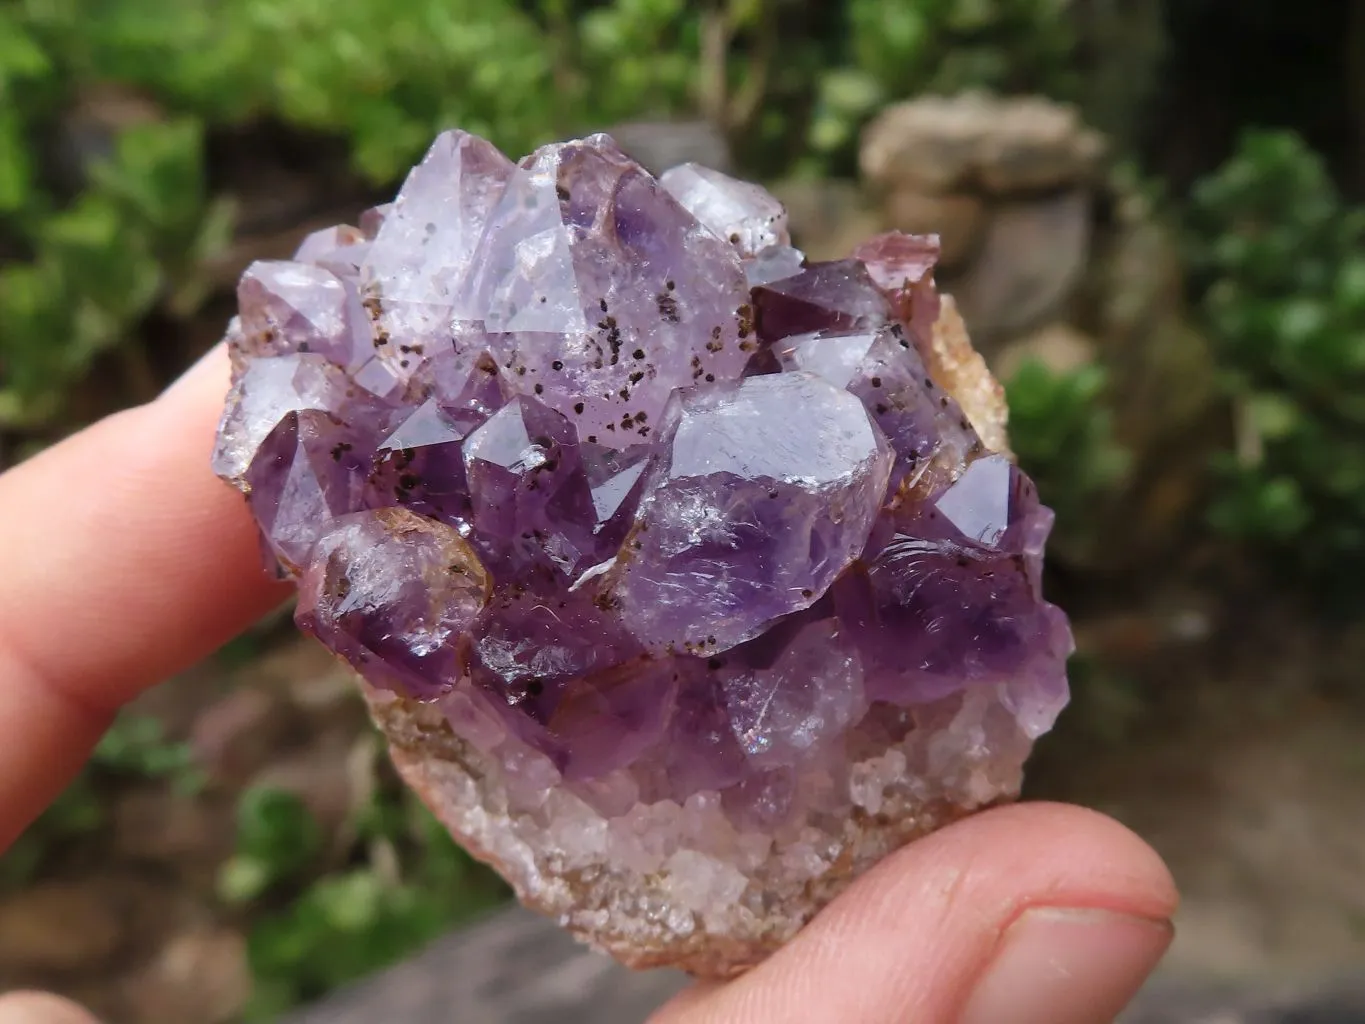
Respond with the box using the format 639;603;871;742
0;347;1177;1024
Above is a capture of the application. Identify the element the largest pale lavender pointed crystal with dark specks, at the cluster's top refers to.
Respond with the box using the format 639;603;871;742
464;135;755;448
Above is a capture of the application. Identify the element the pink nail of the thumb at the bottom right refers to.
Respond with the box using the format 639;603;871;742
962;907;1174;1024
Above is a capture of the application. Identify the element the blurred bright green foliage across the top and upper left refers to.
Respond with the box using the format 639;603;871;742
0;0;1074;430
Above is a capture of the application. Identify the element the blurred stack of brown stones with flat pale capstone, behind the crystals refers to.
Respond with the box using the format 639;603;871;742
860;93;1104;355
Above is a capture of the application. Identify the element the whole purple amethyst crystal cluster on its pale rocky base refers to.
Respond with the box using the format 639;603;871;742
214;131;1070;973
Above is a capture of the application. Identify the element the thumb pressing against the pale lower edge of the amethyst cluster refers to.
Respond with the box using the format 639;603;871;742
652;804;1177;1024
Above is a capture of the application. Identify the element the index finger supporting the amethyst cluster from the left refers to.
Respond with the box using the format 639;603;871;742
0;347;288;848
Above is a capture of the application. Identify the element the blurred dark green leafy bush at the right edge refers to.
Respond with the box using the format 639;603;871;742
1188;131;1365;592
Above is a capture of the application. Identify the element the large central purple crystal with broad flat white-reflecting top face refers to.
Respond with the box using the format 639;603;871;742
605;373;893;654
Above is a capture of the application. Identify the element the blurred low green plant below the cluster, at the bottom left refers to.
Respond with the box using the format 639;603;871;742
220;789;506;1020
